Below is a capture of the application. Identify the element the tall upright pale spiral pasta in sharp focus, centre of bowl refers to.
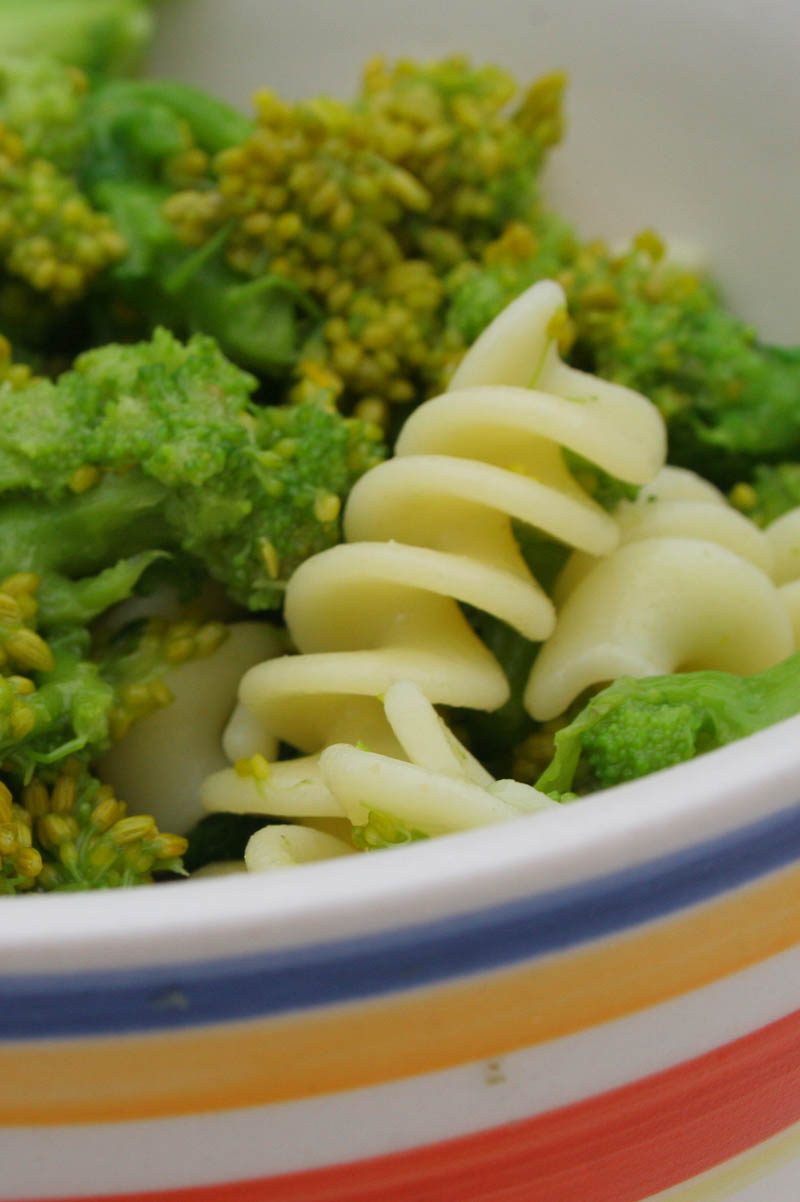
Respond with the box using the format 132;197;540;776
199;281;665;815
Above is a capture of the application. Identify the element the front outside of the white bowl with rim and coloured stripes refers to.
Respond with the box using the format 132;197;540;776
0;720;800;1202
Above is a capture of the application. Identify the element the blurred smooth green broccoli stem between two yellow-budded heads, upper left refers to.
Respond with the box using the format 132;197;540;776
69;81;310;371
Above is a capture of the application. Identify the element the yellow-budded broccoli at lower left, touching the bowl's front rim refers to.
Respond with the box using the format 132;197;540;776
0;572;240;894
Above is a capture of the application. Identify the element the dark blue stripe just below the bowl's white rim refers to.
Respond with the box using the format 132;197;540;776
0;803;800;1040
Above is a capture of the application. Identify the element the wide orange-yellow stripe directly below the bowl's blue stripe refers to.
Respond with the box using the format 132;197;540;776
0;868;800;1125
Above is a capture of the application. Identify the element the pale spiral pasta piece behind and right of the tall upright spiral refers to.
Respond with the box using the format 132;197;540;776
525;468;794;720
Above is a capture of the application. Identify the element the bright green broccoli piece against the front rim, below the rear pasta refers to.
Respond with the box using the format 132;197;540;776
537;653;800;796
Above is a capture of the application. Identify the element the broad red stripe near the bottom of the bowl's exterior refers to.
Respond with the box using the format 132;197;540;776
17;1011;800;1202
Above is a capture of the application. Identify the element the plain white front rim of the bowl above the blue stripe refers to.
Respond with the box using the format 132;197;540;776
6;715;800;980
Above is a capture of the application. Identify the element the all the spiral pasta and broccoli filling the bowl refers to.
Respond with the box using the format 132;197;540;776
0;11;800;893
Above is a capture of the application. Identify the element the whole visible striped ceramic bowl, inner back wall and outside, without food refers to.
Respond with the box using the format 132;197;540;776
0;0;800;1202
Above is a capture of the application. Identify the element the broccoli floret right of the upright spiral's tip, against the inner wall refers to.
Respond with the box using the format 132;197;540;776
571;236;800;486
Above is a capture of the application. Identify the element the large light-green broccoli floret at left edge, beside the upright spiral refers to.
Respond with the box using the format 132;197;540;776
0;331;382;609
